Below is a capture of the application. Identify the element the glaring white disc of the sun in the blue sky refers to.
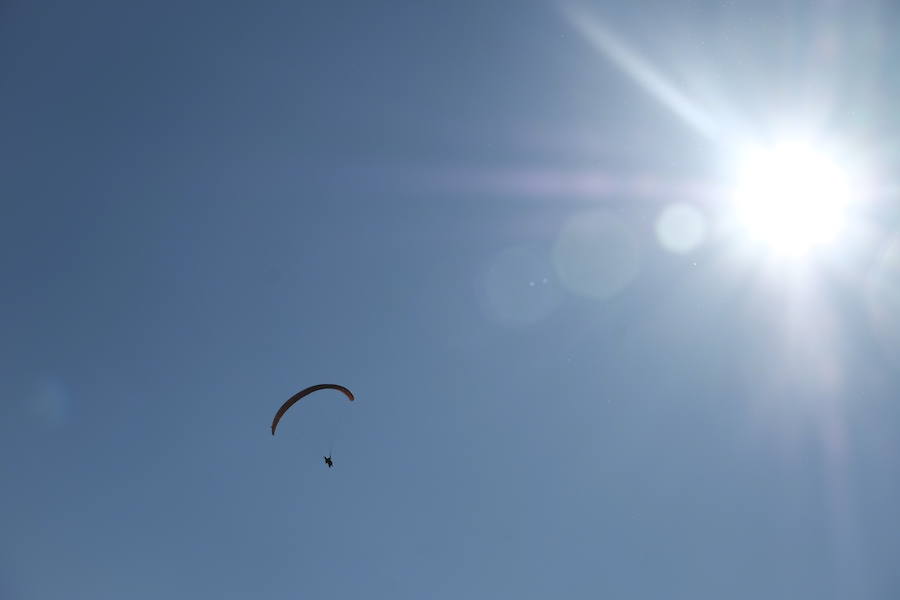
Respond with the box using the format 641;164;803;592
734;142;853;256
